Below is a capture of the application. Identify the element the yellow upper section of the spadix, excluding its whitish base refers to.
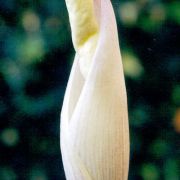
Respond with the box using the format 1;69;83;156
66;0;99;47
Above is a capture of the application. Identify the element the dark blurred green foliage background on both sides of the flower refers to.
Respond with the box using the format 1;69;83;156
0;0;180;180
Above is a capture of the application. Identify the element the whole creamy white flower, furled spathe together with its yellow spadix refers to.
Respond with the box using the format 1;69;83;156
61;0;129;180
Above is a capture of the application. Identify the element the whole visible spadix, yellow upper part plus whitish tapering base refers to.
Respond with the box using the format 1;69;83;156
66;0;99;78
